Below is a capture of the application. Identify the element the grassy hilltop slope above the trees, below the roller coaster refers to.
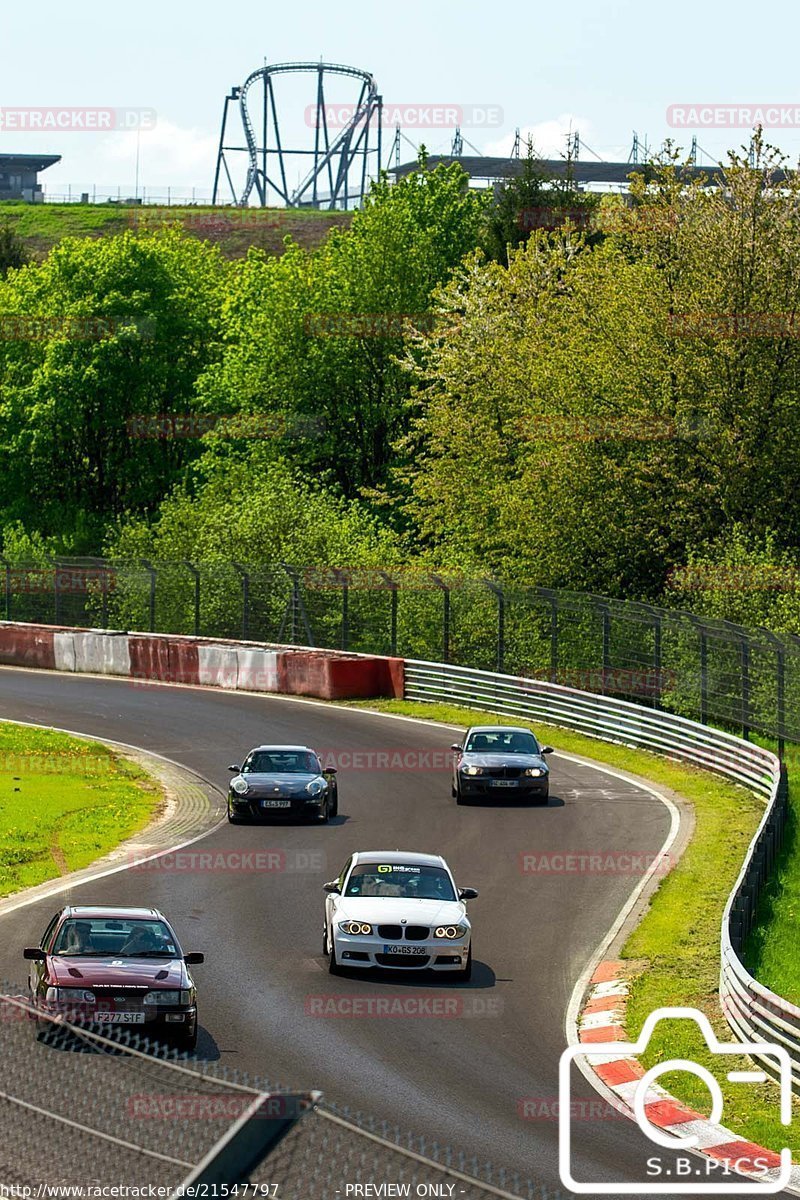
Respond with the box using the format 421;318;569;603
0;200;353;258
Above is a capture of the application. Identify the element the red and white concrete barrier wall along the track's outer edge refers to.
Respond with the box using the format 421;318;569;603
0;622;404;700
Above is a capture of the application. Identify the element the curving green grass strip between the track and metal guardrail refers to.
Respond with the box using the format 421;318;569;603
357;701;800;1159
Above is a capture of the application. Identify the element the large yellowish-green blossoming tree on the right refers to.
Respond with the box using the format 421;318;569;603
397;138;800;598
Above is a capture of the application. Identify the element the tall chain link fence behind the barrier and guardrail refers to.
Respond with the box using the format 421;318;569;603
0;558;800;744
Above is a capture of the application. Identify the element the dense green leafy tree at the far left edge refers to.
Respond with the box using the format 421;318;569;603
0;230;223;551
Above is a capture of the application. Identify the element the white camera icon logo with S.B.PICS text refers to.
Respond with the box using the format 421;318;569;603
559;1008;792;1195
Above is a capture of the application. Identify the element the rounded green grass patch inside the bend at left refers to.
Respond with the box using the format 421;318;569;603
0;721;162;895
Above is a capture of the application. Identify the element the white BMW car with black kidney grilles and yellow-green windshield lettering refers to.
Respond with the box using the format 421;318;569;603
323;850;477;979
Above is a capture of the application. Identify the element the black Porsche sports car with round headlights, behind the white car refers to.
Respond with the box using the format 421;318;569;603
228;746;338;824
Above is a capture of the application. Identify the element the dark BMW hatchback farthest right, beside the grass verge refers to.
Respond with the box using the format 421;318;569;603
451;725;553;804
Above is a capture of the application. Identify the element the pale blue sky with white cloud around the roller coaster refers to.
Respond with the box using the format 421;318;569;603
0;0;800;198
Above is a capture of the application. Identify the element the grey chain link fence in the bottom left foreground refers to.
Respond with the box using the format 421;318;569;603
0;983;544;1200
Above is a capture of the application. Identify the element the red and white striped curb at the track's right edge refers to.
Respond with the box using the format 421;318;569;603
578;961;800;1190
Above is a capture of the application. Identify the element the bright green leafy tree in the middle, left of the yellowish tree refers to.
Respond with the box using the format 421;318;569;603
198;166;487;496
